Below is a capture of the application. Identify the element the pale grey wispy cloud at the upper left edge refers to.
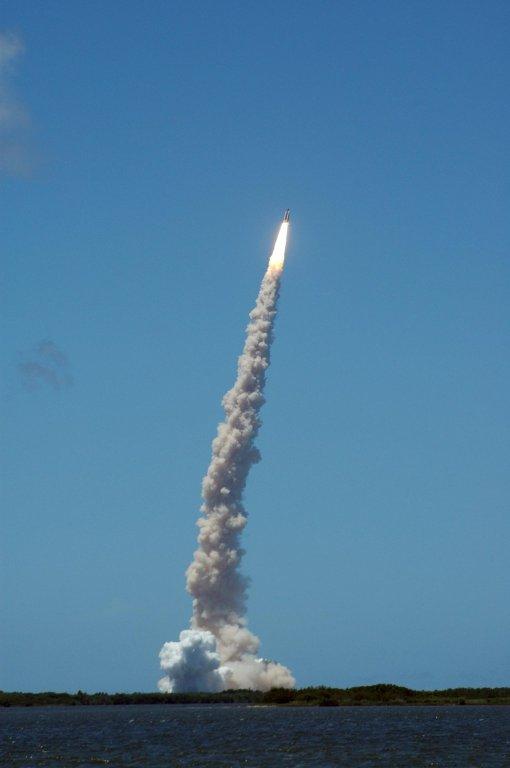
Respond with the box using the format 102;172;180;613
0;32;33;176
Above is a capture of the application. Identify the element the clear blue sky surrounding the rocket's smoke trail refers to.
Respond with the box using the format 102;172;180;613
0;0;510;691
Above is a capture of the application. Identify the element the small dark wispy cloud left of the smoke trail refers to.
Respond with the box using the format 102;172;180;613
18;339;73;391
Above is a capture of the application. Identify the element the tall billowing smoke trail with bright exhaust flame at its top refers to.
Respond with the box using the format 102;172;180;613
159;220;294;691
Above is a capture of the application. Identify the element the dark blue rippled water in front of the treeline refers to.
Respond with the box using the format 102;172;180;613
0;704;510;768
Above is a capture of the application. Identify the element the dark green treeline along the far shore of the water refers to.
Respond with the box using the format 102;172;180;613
0;683;510;707
